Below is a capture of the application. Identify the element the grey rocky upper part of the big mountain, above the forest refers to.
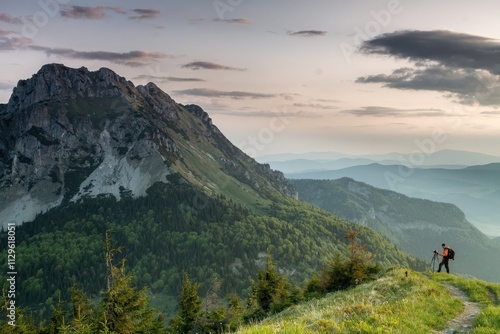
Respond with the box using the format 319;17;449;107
0;64;295;225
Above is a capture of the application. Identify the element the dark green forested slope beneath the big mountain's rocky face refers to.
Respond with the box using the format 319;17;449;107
0;177;423;314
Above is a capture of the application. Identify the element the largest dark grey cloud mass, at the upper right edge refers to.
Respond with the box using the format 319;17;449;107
356;30;500;105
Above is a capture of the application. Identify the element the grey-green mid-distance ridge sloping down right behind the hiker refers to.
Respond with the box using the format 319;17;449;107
291;178;500;281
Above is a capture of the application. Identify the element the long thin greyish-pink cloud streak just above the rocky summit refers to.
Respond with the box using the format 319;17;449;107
30;45;167;67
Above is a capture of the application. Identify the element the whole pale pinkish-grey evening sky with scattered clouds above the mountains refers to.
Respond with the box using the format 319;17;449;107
0;0;500;157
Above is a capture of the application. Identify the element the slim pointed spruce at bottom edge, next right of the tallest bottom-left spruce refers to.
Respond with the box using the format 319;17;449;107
170;273;201;333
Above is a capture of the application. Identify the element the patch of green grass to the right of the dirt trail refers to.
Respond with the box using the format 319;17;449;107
431;274;500;334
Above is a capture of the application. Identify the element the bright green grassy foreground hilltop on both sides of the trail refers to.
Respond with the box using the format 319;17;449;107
237;269;500;334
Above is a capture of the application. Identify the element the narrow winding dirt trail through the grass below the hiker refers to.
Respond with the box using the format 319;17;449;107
437;284;481;334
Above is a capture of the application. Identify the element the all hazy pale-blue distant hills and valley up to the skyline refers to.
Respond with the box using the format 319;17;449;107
260;150;500;237
